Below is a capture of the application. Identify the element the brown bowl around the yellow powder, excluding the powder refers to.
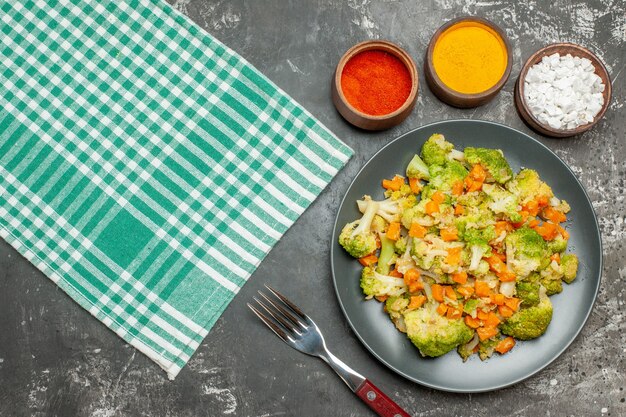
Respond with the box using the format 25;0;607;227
424;16;513;108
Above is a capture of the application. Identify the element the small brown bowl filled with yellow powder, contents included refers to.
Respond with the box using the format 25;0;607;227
424;16;513;108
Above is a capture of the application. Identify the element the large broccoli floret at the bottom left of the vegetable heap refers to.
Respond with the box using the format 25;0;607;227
404;302;474;357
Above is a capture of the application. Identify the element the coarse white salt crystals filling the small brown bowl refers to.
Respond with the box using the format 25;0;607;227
524;54;606;129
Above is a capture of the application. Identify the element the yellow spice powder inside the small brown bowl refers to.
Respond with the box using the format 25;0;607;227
433;22;507;94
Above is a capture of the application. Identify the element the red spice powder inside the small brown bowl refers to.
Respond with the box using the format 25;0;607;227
341;50;412;116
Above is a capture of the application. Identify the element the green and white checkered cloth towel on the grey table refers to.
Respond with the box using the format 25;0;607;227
0;0;352;378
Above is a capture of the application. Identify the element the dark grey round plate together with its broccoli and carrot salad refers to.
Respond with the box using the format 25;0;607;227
331;120;602;392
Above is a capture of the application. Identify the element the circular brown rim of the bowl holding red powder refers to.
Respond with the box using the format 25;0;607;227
334;39;419;120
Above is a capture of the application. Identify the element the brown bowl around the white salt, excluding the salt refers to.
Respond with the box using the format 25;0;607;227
515;43;611;138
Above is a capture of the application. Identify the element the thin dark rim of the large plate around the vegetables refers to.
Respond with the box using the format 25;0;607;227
330;119;604;393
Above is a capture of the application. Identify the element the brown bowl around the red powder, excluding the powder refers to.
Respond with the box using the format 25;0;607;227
331;41;419;130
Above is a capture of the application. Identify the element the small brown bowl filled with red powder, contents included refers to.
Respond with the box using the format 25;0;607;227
332;41;418;130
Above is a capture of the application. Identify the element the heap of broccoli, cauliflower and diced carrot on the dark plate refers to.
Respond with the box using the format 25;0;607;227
339;134;578;360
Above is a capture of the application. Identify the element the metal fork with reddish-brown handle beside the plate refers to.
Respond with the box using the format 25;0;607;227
247;285;410;417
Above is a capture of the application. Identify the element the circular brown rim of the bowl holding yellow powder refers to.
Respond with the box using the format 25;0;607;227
426;16;513;99
